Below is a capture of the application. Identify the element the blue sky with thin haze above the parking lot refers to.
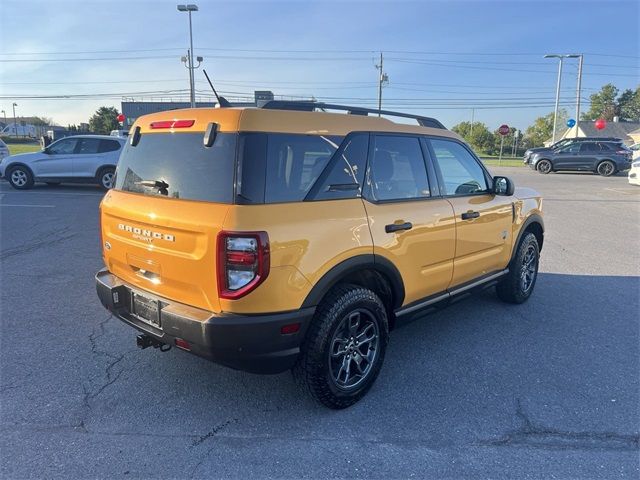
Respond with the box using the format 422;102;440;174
0;0;640;129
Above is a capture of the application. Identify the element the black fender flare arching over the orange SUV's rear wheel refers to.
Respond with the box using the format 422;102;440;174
300;254;404;309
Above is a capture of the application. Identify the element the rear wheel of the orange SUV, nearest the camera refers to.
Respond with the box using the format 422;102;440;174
293;285;389;409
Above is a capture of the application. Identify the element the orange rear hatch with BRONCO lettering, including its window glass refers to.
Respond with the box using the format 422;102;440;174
101;126;237;312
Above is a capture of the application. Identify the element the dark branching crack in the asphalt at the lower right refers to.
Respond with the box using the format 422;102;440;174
480;399;640;450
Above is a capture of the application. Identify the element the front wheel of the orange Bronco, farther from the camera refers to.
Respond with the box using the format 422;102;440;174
496;233;540;303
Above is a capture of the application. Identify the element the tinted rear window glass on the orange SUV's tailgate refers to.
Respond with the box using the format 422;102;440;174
115;132;238;203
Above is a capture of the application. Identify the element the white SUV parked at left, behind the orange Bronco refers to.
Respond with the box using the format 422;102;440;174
0;135;125;190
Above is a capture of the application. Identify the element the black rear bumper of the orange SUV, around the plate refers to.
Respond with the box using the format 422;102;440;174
96;269;315;374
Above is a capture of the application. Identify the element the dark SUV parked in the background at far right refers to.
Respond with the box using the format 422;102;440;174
528;141;631;177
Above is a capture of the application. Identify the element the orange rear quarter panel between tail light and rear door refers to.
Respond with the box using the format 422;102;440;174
220;199;373;313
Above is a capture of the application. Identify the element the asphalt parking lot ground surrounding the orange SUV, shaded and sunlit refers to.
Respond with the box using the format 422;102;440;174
0;168;640;479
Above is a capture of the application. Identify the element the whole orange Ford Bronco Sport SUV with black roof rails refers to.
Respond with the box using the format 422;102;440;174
96;101;543;408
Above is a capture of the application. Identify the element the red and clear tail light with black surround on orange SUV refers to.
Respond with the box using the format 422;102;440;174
217;231;270;300
